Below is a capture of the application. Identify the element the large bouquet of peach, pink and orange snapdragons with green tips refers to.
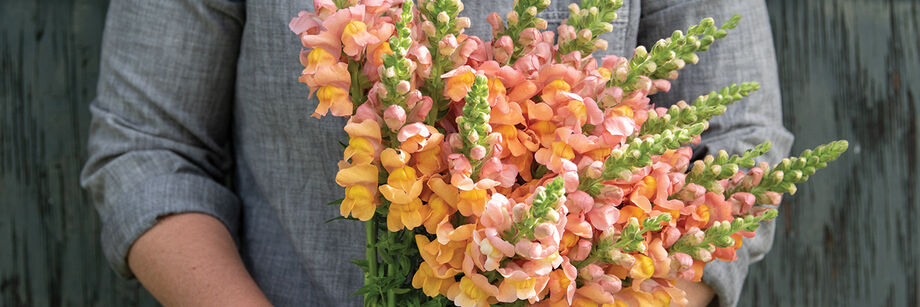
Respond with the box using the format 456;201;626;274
290;0;847;306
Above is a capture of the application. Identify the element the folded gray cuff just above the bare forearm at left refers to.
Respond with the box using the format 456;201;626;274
100;173;239;278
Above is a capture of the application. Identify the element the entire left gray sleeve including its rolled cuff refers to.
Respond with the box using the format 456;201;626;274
81;0;244;278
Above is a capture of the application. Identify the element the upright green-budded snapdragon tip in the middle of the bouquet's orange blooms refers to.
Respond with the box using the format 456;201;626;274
457;75;492;180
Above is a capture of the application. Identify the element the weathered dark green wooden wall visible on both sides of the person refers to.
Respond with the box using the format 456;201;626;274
0;0;920;306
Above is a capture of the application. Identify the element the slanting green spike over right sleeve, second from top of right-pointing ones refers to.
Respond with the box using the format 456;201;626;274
639;82;760;135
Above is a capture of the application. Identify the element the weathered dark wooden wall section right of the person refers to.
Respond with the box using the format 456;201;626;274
740;0;920;306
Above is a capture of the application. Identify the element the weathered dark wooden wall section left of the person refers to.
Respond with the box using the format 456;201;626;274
0;0;155;306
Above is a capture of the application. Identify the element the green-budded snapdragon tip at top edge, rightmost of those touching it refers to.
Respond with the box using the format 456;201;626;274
559;0;623;56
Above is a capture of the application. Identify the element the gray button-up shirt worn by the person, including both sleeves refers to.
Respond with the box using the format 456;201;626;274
82;0;792;306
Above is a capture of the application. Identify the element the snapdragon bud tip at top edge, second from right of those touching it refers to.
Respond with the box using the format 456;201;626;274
492;0;550;64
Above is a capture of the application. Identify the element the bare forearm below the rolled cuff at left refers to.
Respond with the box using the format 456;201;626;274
128;213;271;306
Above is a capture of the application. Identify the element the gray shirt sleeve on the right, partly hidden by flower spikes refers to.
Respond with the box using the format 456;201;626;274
638;0;793;306
